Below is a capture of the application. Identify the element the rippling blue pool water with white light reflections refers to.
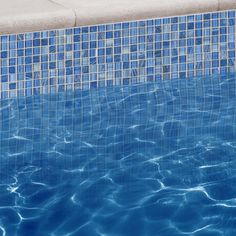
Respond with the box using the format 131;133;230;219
0;76;236;236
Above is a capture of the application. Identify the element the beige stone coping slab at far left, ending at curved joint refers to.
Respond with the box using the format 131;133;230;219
0;0;75;34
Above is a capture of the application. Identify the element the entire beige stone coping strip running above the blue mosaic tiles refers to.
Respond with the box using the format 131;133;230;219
0;0;236;34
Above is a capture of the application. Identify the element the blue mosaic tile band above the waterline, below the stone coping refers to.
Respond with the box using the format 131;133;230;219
0;10;236;99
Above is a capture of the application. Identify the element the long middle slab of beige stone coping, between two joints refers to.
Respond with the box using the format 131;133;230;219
53;0;219;26
